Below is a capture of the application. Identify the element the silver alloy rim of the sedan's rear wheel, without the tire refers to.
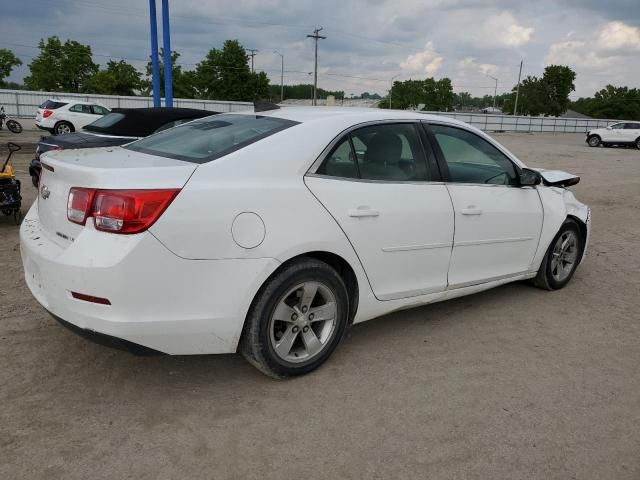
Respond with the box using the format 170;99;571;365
269;281;337;363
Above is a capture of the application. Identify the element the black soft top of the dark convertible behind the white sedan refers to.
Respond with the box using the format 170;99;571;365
84;107;218;137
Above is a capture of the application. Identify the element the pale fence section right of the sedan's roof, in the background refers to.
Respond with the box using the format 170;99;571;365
418;112;618;133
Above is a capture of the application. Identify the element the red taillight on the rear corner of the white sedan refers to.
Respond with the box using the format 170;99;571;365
67;187;180;233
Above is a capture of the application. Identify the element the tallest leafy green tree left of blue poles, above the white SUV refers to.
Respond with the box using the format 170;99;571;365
24;36;99;92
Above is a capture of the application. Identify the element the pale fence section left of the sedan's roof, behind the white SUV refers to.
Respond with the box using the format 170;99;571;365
0;89;253;118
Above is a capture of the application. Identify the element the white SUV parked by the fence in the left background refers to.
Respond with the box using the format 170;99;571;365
36;98;110;135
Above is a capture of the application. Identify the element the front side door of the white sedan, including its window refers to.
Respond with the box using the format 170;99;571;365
428;124;543;288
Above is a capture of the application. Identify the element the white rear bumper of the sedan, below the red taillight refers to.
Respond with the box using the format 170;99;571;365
20;203;279;354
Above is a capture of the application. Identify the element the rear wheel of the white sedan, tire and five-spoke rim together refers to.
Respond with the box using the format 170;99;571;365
239;257;349;378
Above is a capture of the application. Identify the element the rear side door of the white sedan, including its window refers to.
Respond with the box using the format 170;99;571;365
305;122;453;300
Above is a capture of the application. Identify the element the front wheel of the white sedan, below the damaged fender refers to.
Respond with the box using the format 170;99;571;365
533;219;584;290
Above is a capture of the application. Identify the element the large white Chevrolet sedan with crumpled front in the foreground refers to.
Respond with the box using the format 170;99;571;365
20;108;590;377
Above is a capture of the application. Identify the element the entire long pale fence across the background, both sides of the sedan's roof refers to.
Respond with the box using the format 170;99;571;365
0;89;617;133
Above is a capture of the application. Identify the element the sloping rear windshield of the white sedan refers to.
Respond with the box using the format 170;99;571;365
125;114;298;163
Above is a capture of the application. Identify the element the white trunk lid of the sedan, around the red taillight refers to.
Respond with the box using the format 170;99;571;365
37;147;197;247
